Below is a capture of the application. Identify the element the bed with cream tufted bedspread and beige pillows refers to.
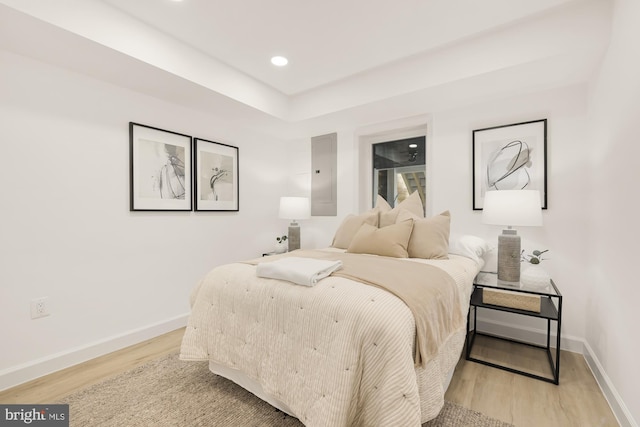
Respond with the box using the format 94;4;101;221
180;196;483;427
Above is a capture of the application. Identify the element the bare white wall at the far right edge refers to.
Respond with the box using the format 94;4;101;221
585;0;640;425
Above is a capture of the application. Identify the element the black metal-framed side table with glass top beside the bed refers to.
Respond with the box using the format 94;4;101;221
466;273;562;385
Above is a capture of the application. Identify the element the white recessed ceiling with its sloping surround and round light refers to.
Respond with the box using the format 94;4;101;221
0;0;610;137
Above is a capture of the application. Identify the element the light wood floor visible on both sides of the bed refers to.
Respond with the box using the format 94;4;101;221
0;329;618;427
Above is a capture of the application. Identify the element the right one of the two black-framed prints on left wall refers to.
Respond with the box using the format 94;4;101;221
193;138;240;211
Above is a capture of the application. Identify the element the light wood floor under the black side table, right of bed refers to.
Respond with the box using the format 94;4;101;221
445;336;619;427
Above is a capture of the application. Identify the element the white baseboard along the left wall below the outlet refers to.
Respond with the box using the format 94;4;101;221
0;313;189;391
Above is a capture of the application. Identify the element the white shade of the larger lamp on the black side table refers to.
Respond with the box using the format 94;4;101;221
482;190;542;226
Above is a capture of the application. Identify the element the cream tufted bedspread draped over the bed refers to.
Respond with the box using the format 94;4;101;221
180;251;481;427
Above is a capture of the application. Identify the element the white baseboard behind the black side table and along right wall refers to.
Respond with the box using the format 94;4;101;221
478;317;640;427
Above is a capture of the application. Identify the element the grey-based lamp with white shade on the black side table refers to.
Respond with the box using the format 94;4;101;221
482;190;542;284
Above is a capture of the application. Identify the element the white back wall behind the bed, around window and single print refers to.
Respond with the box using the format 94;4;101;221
290;84;591;344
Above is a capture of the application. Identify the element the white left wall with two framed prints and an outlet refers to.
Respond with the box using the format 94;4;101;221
0;51;286;389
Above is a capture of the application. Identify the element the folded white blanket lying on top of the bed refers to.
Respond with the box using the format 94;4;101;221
256;257;342;286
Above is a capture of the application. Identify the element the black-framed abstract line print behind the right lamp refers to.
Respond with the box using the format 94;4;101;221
473;119;547;210
